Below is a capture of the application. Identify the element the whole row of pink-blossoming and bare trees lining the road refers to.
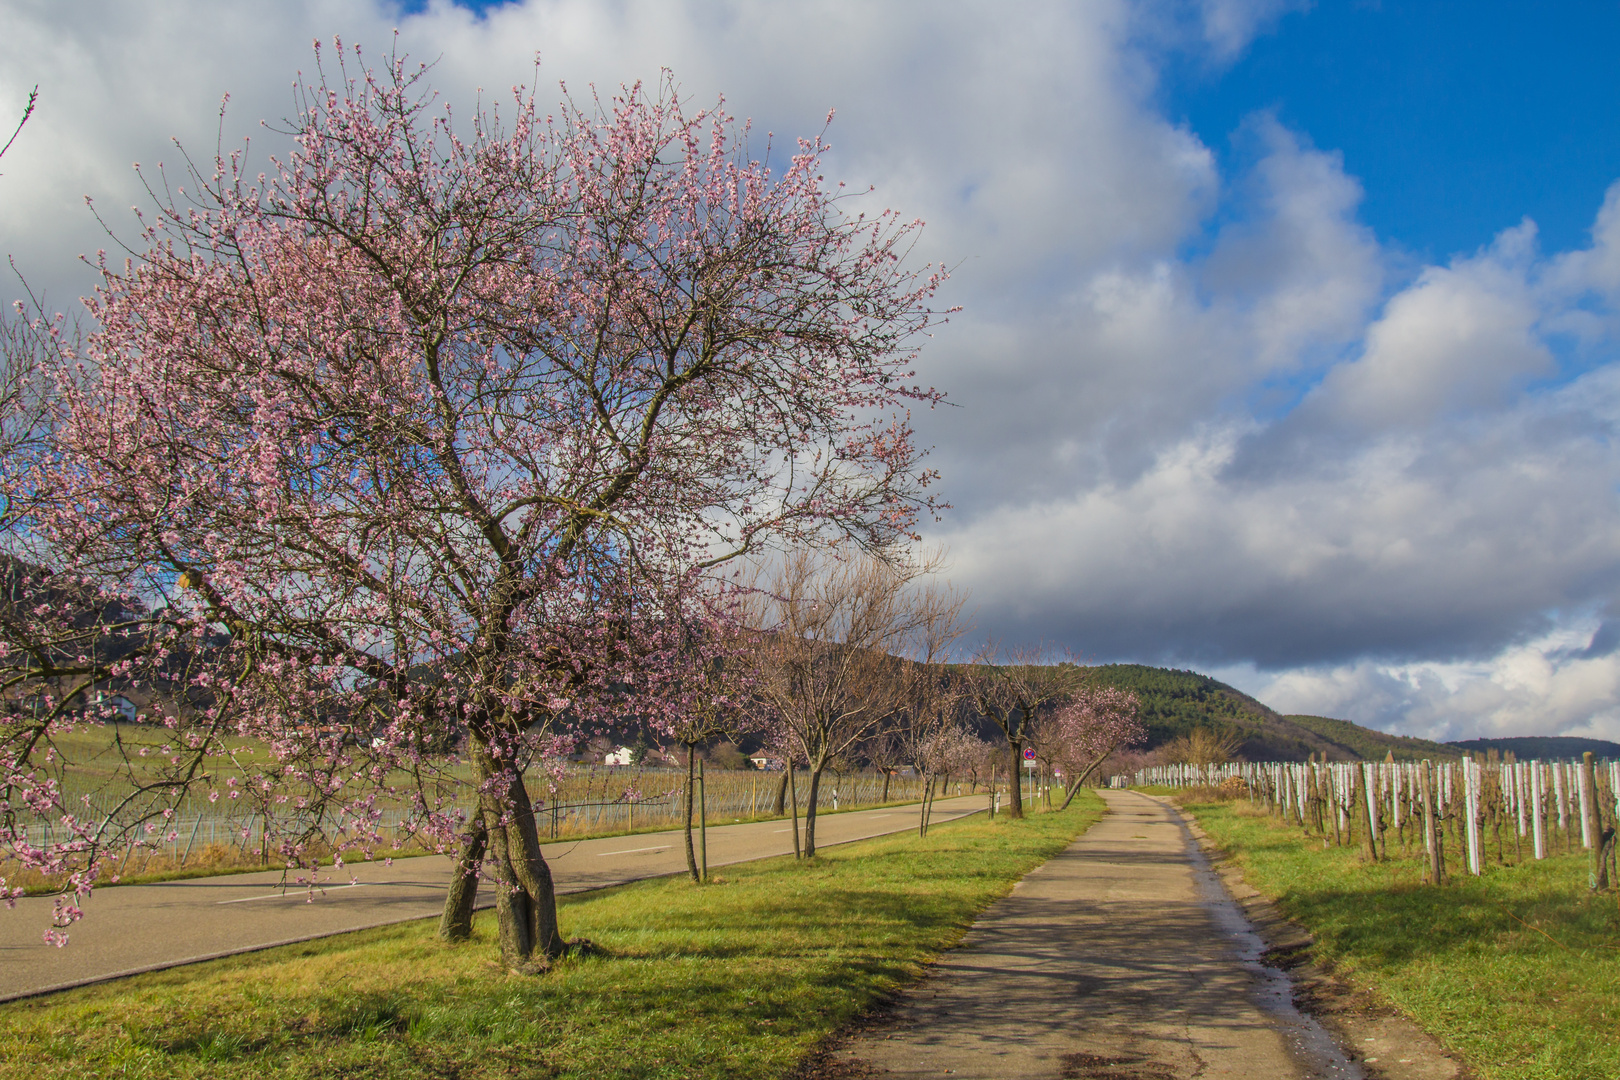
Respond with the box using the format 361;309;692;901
0;47;1131;970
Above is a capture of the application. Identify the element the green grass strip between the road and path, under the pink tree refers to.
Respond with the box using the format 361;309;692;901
0;792;1102;1080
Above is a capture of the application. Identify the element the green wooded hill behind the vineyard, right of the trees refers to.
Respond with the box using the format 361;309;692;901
1087;664;1461;761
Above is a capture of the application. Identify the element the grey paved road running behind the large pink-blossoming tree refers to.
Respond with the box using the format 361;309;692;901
0;795;985;1001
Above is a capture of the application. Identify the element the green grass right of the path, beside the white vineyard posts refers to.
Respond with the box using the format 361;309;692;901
1186;803;1620;1080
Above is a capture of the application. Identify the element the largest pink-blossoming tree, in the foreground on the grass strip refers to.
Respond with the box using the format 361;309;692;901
0;46;940;968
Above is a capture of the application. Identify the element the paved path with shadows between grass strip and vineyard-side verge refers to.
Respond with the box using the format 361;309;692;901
833;790;1362;1080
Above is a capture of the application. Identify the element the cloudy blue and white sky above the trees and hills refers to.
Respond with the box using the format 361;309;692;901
0;0;1620;738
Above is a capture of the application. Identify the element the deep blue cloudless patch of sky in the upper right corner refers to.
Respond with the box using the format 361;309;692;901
1162;0;1620;261
